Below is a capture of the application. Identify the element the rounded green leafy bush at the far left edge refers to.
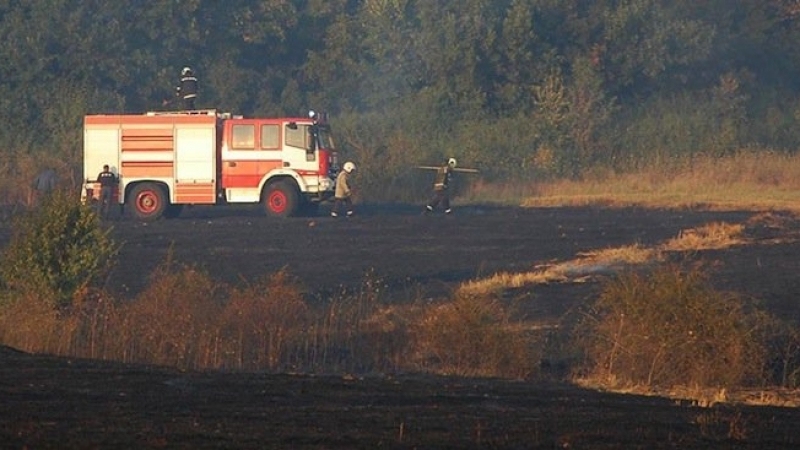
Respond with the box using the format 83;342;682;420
0;191;119;310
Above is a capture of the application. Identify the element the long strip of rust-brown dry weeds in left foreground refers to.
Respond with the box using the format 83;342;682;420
0;262;538;378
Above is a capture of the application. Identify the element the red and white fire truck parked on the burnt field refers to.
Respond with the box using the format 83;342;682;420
83;110;339;220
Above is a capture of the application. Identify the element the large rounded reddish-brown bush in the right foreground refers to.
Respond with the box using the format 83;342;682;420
579;265;766;388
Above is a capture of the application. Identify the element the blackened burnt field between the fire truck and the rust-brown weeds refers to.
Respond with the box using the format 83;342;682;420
92;205;764;296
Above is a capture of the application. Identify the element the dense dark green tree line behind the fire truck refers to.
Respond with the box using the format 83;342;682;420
0;0;800;193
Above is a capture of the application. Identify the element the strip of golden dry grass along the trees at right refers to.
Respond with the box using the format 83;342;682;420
463;150;800;212
